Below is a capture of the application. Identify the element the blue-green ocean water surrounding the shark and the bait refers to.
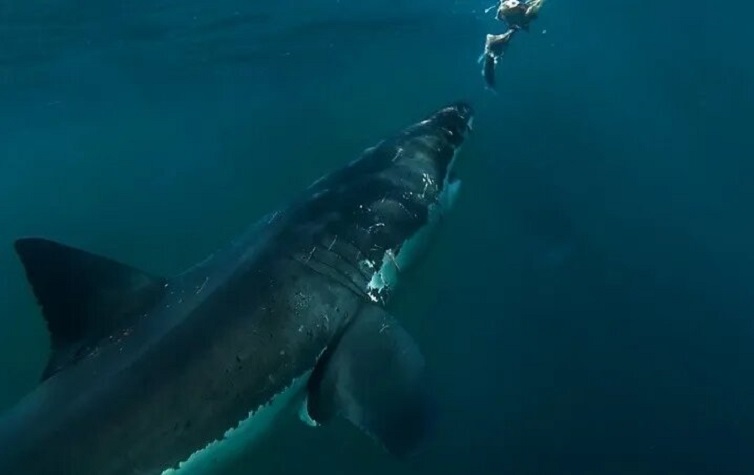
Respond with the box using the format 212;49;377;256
0;0;754;475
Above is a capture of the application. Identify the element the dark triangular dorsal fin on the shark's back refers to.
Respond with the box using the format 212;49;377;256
15;238;167;380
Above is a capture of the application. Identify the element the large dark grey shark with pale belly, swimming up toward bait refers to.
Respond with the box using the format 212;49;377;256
0;102;473;475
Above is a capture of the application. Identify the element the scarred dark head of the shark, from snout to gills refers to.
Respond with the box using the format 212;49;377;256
296;102;474;303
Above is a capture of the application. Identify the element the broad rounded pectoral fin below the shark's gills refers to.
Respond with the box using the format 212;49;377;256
307;305;434;457
